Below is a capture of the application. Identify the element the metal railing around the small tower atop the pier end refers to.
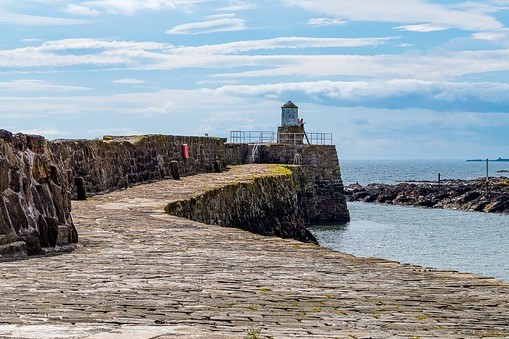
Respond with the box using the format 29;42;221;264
230;131;333;145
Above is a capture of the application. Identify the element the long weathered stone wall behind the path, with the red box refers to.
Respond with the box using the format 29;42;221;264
50;135;247;198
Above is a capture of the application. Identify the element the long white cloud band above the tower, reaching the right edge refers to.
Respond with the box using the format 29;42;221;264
211;50;509;80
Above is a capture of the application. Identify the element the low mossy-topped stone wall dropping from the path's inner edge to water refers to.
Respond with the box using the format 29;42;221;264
165;166;316;243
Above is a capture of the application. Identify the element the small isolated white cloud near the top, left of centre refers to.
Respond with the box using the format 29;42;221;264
166;16;247;34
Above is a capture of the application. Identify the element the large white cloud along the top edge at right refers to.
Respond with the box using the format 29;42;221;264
285;0;503;30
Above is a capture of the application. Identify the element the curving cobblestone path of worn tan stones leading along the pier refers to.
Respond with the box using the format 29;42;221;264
0;165;509;339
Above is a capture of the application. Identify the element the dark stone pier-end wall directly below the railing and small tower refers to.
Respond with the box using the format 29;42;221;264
255;144;350;223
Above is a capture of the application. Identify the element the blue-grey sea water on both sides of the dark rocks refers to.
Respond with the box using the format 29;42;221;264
310;160;509;282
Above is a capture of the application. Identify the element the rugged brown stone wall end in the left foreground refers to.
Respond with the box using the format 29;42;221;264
0;130;78;257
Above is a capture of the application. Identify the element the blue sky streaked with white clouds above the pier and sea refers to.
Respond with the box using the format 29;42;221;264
0;0;509;159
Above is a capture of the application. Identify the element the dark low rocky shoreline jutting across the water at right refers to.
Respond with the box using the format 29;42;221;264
345;177;509;214
